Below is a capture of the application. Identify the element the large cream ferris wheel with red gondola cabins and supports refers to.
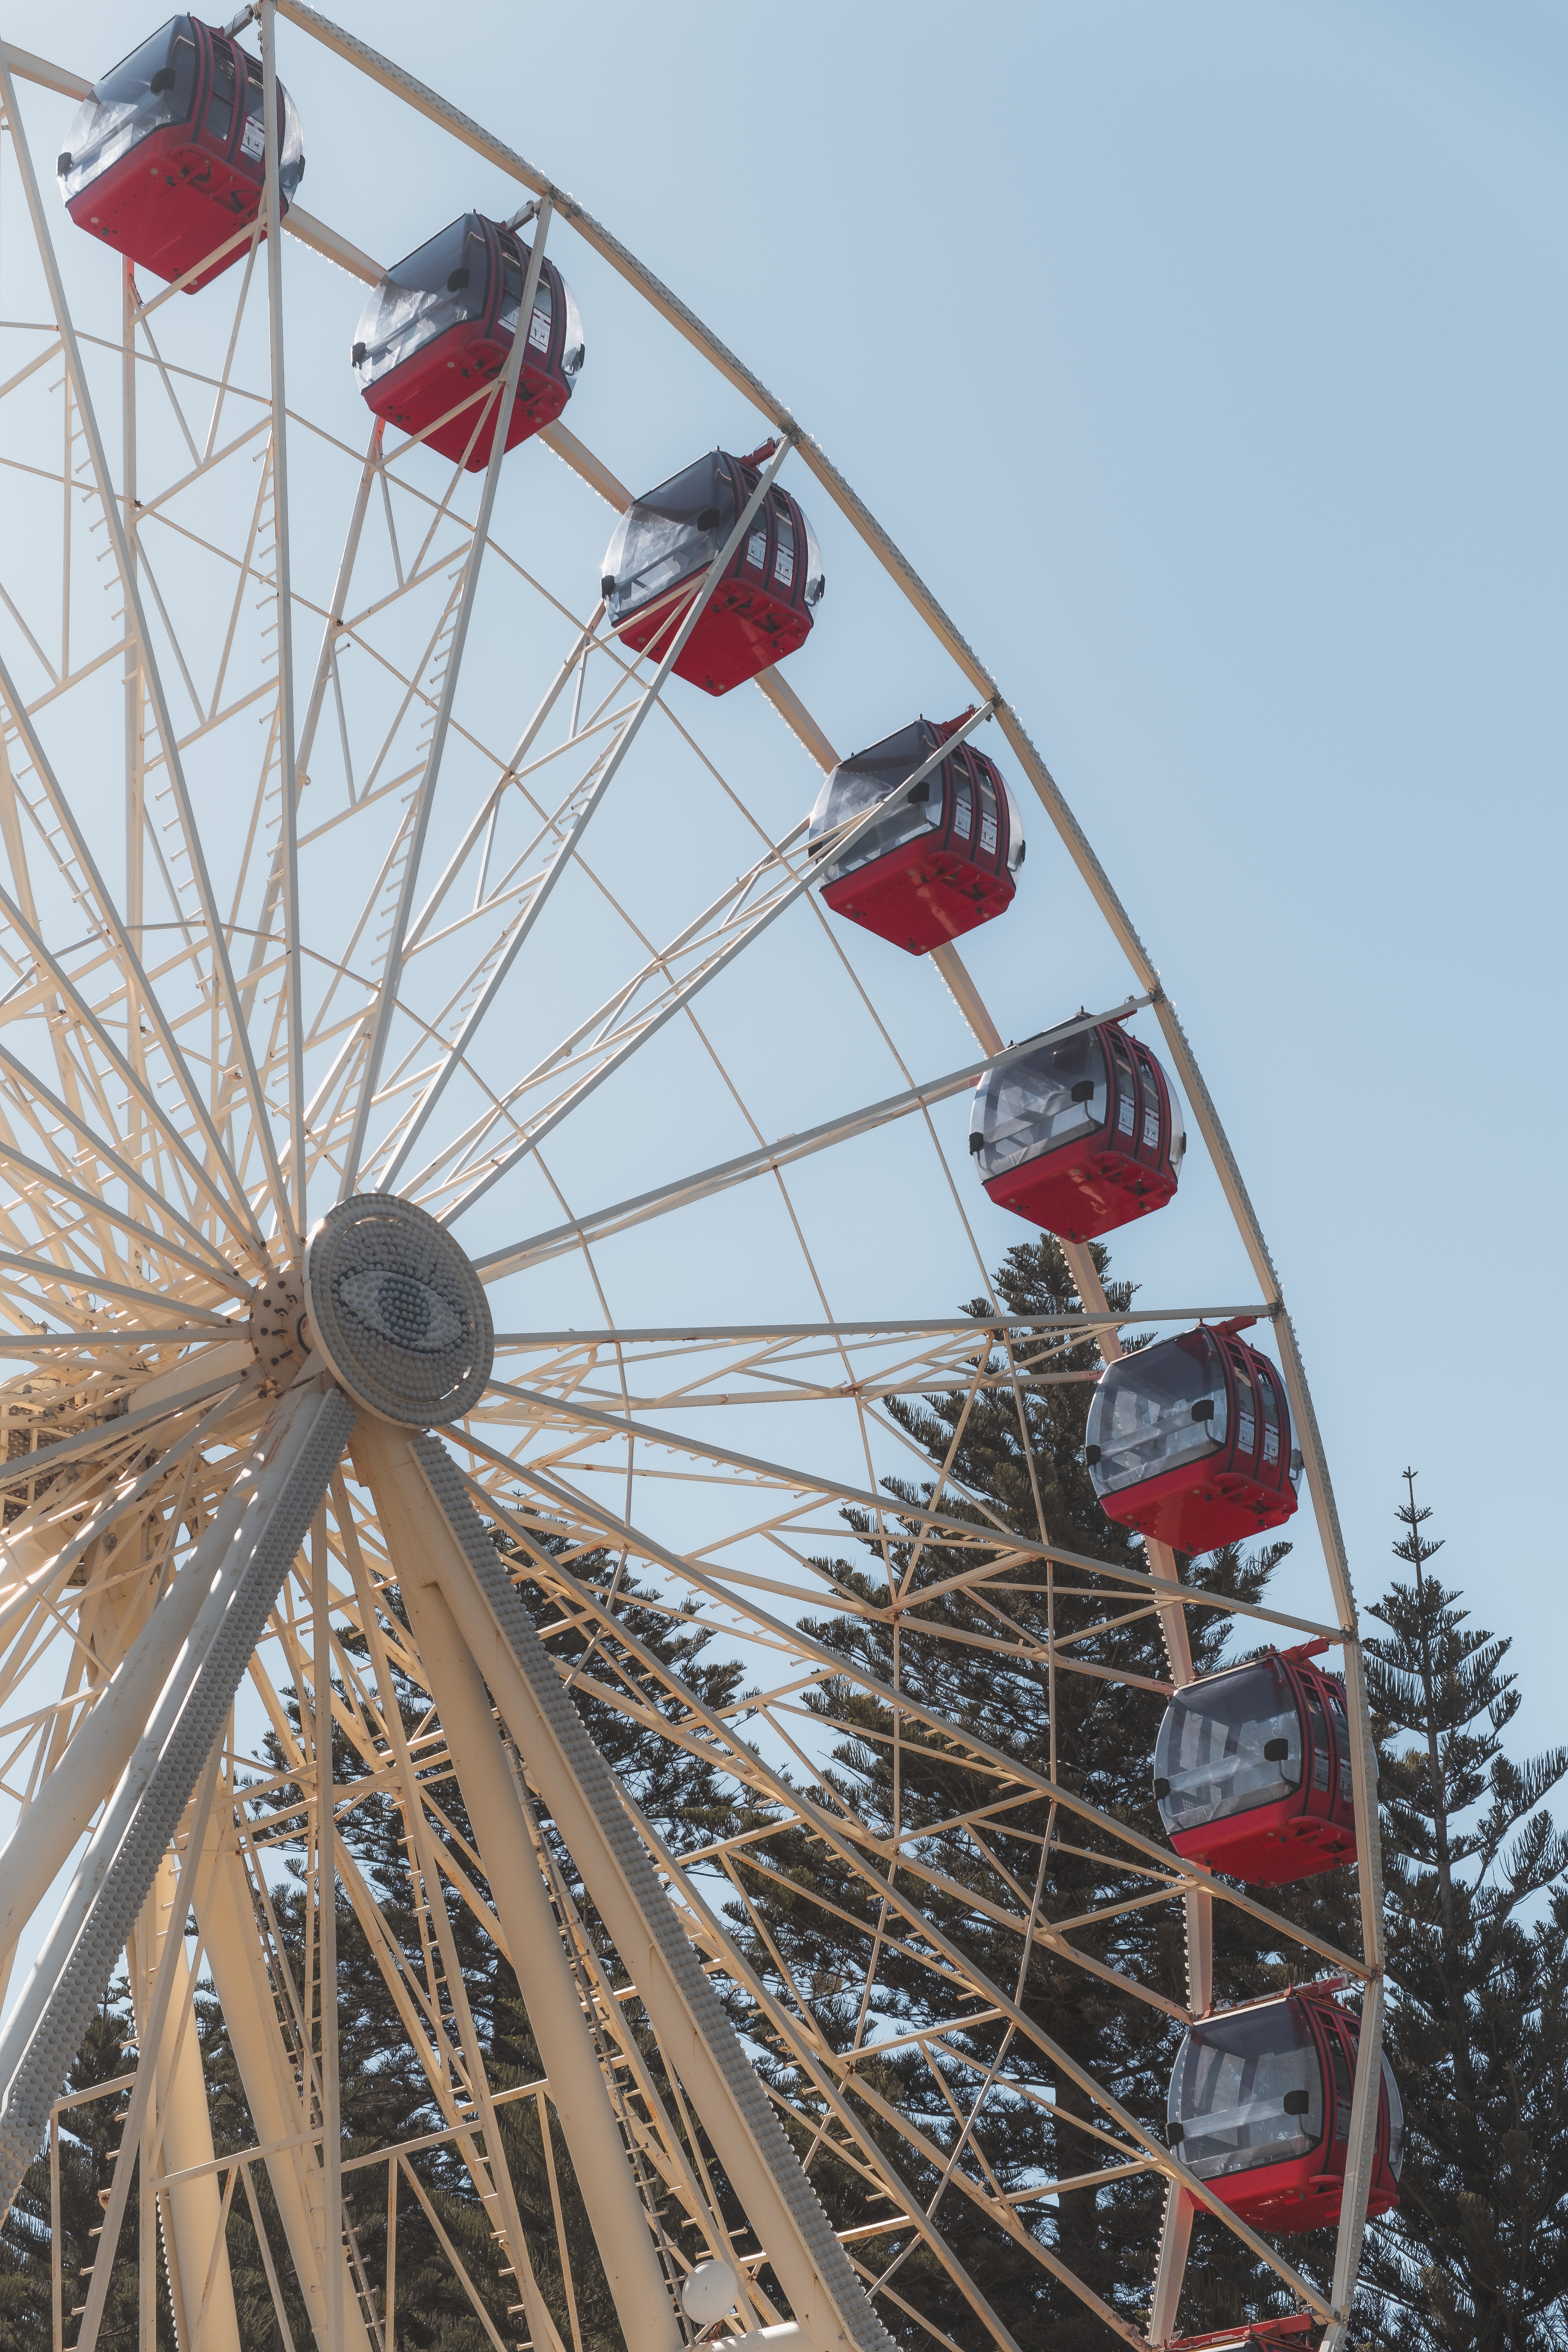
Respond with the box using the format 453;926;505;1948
0;18;1399;2352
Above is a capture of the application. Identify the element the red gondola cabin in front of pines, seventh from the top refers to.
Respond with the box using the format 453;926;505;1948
1154;1642;1356;1886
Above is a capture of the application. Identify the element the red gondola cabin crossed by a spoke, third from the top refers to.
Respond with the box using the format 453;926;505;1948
599;442;825;694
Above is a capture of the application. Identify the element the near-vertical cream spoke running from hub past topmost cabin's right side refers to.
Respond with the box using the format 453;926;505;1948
261;0;303;1251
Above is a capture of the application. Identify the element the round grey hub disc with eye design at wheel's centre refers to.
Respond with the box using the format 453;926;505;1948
305;1192;496;1430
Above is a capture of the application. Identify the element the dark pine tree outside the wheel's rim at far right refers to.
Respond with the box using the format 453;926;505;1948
1366;1470;1568;2352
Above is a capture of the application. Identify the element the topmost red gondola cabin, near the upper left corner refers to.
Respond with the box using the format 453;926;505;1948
54;16;305;294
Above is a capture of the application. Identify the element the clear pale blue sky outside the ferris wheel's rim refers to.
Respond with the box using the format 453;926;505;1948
5;0;1568;1745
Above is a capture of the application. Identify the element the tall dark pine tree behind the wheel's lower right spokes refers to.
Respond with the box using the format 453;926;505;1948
710;1235;1352;2352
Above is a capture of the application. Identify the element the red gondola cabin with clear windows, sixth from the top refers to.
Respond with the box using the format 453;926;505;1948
1084;1324;1300;1552
